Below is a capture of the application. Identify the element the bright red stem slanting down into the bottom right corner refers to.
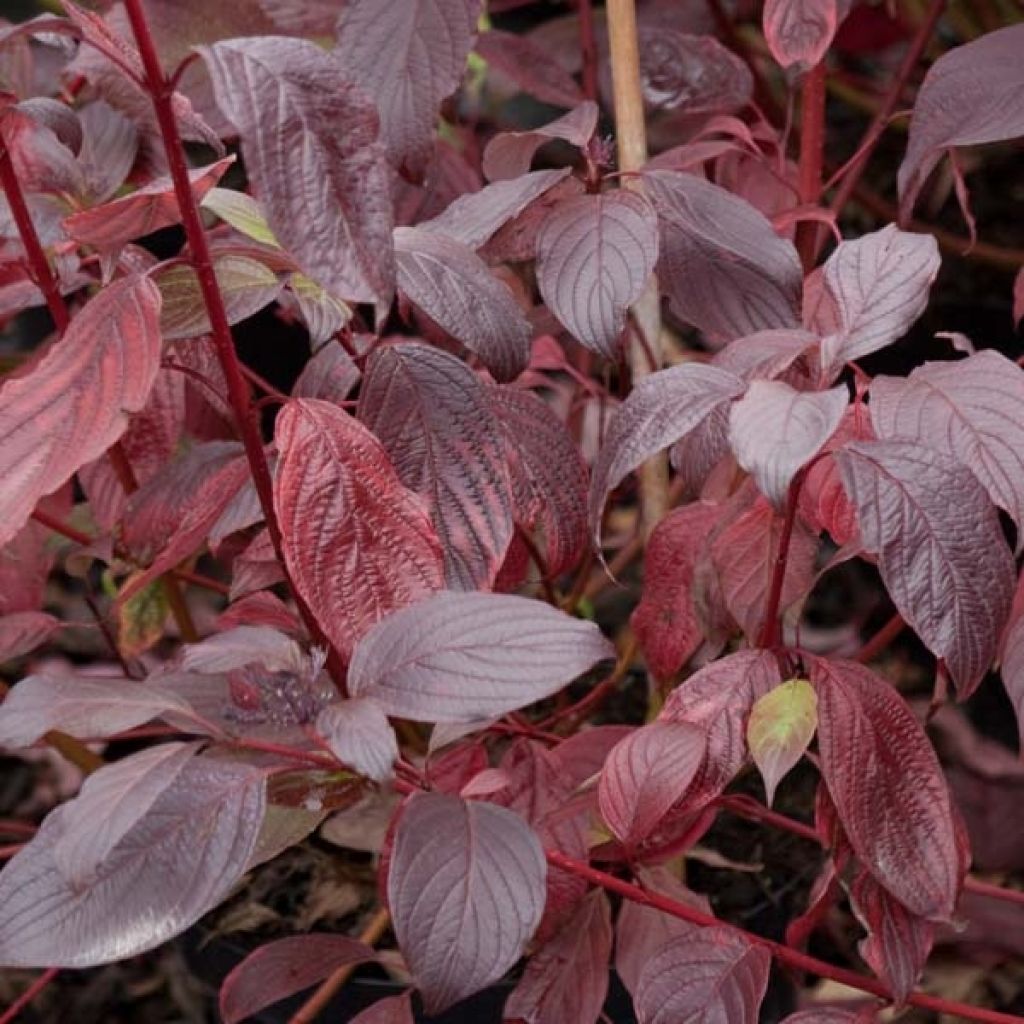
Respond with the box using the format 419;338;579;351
545;850;1024;1024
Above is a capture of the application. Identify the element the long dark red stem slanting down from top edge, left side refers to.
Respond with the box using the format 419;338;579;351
125;0;346;695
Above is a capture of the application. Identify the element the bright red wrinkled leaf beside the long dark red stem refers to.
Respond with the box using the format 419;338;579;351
273;398;443;656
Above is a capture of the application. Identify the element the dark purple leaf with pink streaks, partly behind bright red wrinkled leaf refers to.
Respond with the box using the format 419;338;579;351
357;342;514;590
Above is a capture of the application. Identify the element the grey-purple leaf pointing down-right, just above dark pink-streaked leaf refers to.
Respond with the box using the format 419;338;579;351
394;227;534;380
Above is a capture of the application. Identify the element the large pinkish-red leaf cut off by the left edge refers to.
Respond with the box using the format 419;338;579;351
0;276;160;544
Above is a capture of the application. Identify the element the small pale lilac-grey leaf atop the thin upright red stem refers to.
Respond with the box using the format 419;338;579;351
729;381;850;510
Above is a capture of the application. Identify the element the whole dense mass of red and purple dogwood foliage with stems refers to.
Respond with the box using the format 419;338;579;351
0;0;1024;1024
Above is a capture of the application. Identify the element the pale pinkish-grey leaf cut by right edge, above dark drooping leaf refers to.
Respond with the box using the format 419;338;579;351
868;350;1024;552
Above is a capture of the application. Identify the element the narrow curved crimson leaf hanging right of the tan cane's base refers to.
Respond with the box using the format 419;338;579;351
630;502;721;680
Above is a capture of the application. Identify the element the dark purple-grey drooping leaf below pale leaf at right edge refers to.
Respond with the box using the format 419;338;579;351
835;441;1015;696
